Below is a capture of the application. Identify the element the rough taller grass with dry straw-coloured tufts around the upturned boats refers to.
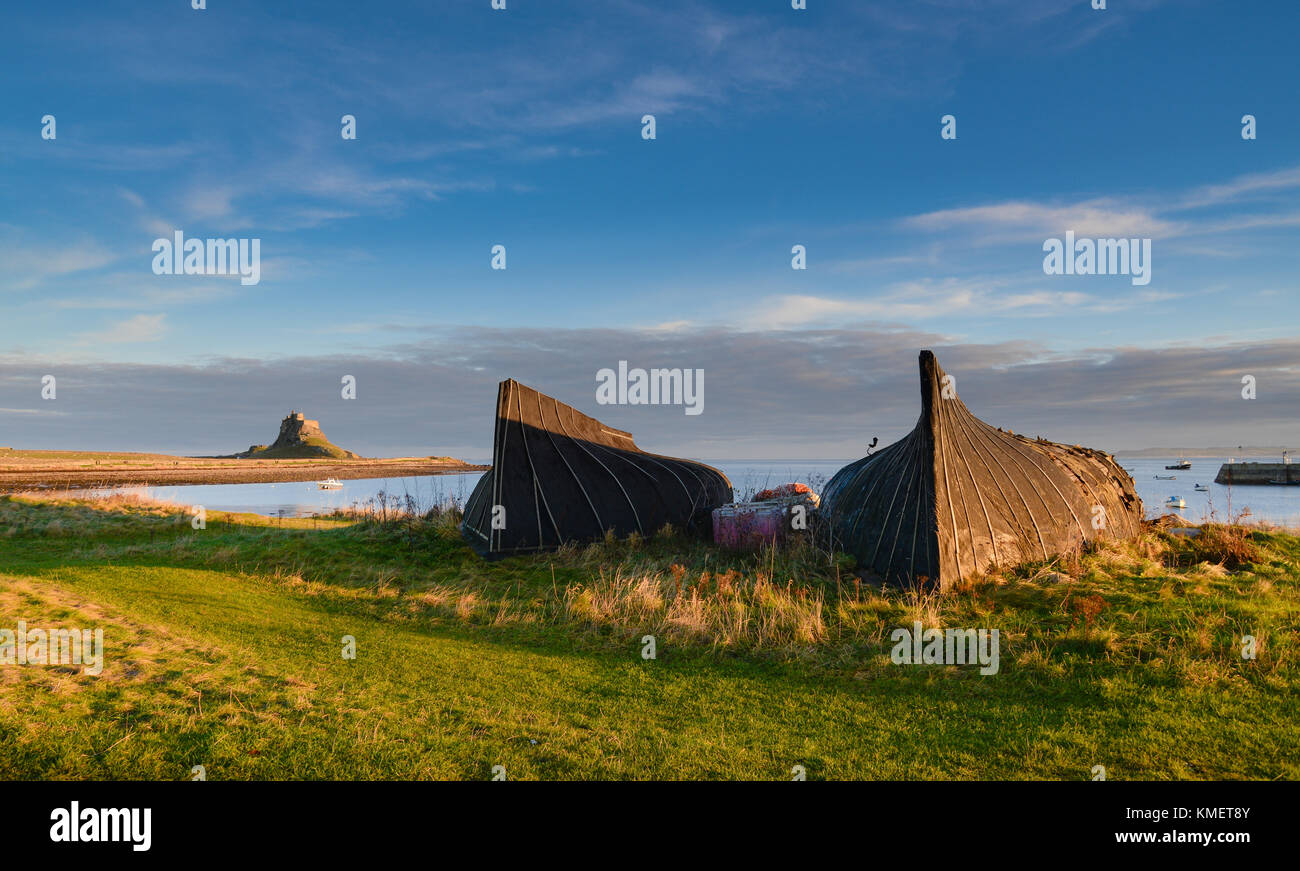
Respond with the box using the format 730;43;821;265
0;495;1294;676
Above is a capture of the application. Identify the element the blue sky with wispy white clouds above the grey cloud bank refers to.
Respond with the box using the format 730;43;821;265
0;0;1300;455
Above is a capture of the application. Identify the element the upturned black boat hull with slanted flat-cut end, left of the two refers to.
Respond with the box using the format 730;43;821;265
462;380;732;555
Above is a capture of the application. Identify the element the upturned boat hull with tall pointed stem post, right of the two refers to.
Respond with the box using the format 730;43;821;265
822;351;1143;589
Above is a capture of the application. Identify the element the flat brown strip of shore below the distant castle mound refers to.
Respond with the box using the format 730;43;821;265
0;449;489;491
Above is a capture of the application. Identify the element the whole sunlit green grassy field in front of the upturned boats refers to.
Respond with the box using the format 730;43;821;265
0;497;1300;780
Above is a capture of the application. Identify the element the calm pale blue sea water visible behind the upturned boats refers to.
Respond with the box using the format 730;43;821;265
78;458;1300;527
